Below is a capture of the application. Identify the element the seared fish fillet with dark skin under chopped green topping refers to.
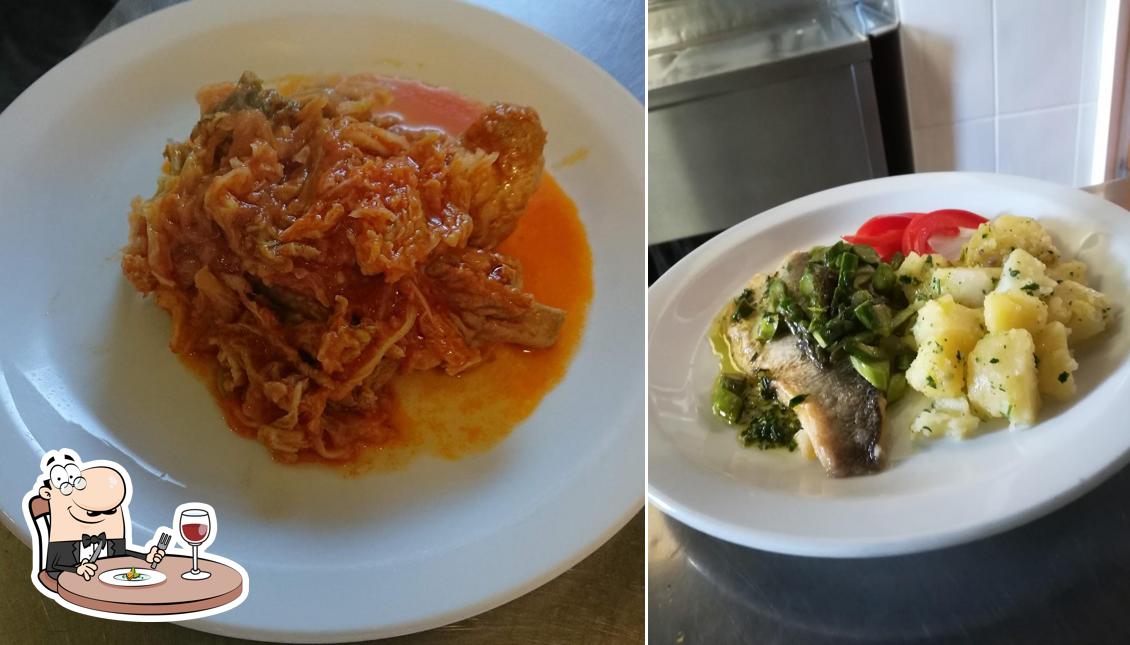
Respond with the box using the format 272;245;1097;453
722;252;886;477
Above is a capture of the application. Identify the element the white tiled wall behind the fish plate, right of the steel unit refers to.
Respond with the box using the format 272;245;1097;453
899;0;1118;185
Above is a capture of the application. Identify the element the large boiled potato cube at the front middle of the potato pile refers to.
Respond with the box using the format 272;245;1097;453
966;329;1040;426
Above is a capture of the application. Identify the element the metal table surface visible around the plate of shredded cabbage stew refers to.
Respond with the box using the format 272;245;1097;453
0;0;644;645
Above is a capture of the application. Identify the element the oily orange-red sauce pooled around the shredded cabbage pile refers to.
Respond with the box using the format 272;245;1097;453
206;77;592;472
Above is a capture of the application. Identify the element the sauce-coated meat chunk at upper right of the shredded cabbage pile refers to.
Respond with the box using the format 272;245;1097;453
462;103;546;249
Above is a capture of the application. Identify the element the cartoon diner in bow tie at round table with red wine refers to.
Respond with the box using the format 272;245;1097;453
24;448;249;621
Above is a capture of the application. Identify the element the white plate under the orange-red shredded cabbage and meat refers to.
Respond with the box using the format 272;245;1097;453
0;0;644;640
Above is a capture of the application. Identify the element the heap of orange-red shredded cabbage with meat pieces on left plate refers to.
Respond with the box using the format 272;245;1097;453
122;73;565;461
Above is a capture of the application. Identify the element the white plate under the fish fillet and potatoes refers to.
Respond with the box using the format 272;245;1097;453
647;173;1130;557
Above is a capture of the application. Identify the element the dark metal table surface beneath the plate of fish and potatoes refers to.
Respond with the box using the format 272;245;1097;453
647;180;1130;645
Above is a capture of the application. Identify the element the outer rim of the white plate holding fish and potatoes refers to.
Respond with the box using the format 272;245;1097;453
647;171;1130;558
